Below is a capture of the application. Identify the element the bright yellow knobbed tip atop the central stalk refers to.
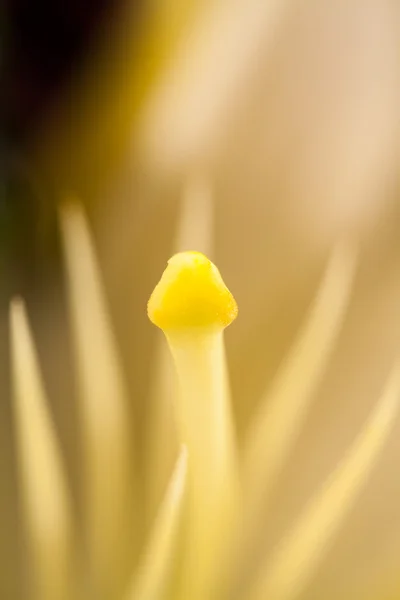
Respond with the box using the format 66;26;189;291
147;252;238;330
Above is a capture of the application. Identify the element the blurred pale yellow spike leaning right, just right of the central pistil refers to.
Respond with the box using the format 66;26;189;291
244;245;356;544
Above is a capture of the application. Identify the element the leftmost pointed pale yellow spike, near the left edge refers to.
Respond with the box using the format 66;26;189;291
10;300;74;600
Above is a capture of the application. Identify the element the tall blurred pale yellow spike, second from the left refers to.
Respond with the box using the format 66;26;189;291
61;204;135;597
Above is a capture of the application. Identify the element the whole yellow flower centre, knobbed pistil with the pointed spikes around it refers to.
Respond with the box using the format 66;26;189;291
10;198;400;600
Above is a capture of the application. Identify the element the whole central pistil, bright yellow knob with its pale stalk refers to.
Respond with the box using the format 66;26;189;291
148;252;238;600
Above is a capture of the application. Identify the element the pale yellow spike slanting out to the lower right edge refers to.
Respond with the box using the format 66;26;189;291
248;365;400;600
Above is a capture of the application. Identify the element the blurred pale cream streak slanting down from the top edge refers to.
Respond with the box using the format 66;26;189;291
140;0;292;171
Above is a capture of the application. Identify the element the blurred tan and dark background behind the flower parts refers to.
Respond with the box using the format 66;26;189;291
0;0;400;600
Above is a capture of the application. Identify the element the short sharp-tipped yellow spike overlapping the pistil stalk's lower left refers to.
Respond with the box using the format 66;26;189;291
126;447;187;600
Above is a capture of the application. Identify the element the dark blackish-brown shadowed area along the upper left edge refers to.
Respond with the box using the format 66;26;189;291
0;0;140;299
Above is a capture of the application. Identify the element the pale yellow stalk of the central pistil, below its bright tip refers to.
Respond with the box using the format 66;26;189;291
167;330;238;600
